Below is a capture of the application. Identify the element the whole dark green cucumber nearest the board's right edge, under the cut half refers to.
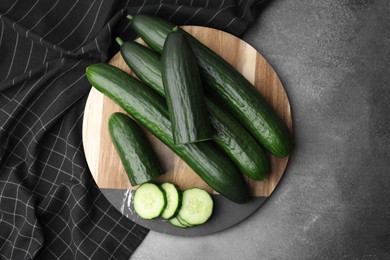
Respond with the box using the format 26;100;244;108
131;15;293;157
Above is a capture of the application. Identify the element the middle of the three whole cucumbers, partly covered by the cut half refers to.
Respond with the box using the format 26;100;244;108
120;41;269;180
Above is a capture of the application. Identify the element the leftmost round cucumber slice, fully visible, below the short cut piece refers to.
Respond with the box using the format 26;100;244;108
134;183;167;219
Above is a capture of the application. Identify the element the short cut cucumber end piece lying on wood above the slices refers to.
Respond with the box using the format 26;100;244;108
108;112;164;186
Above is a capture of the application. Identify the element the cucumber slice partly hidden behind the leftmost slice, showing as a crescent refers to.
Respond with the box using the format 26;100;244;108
160;182;181;219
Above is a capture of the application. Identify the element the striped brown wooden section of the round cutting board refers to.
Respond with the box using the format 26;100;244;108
83;26;292;197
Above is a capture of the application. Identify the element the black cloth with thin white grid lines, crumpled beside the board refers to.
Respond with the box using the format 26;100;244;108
0;0;264;259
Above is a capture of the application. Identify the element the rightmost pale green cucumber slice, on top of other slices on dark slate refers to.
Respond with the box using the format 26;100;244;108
179;188;214;225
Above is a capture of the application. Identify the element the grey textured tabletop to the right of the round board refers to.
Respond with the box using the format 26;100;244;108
131;0;390;260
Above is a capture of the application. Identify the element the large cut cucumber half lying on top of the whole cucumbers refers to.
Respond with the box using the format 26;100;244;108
161;31;214;144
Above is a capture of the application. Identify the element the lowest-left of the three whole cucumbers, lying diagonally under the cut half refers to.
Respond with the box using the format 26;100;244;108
86;63;250;203
